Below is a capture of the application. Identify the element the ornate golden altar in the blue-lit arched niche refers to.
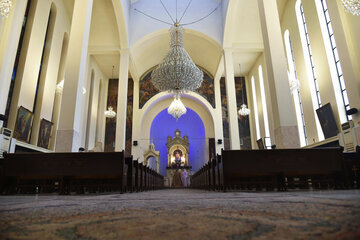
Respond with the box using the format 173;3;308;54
165;129;191;187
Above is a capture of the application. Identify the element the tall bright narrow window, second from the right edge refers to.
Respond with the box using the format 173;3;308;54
295;0;324;141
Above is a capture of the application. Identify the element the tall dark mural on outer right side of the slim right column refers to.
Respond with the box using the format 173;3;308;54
235;77;251;149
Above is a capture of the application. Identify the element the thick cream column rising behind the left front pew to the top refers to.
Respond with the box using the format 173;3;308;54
56;0;93;151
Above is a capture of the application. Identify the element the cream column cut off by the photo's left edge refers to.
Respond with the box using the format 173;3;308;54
0;1;27;128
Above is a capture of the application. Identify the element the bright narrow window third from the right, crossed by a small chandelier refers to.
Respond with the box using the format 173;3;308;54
284;30;308;147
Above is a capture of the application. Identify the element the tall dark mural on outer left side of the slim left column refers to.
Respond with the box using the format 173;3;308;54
104;79;119;152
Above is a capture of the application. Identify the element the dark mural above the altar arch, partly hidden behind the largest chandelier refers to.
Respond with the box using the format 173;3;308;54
139;68;215;108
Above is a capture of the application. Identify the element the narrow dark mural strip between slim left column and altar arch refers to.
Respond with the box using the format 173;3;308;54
125;79;134;157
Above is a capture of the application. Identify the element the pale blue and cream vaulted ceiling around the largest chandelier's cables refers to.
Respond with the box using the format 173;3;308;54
83;0;288;78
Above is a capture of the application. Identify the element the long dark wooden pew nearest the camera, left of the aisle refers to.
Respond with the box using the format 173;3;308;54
3;152;128;194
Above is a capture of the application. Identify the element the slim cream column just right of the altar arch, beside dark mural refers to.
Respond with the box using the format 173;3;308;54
224;49;240;150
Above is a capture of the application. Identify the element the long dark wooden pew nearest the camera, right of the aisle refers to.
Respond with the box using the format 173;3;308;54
219;148;343;190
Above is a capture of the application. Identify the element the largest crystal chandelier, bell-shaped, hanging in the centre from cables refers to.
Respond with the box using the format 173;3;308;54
151;23;204;94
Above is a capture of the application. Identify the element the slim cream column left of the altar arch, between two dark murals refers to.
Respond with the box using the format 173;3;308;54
115;49;129;151
